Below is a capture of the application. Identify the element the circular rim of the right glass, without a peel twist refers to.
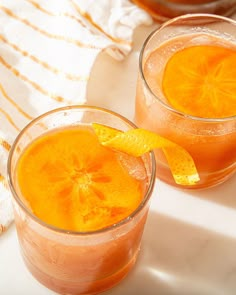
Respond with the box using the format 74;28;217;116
139;13;236;123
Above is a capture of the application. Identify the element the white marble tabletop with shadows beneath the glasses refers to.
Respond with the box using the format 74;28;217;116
0;22;236;295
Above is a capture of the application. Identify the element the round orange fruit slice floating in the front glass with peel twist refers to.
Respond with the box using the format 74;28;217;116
17;126;144;231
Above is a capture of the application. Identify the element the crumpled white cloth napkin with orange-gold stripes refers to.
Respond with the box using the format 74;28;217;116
0;0;152;233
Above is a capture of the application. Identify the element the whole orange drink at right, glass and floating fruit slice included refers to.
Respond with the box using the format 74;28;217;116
135;14;236;189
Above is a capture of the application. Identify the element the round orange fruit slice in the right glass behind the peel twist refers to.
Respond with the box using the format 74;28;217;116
162;45;236;118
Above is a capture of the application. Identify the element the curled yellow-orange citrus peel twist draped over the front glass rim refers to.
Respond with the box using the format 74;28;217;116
92;123;199;185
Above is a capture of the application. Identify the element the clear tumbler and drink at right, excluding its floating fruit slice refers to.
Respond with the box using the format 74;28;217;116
135;14;236;189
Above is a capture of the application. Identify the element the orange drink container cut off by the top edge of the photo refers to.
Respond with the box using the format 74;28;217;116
133;0;236;21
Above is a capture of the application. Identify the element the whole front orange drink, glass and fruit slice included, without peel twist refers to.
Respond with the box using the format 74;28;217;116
8;106;155;294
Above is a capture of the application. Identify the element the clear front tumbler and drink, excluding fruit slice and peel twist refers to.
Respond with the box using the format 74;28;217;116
8;106;155;294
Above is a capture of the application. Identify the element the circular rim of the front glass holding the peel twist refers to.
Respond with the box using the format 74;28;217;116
7;105;156;236
